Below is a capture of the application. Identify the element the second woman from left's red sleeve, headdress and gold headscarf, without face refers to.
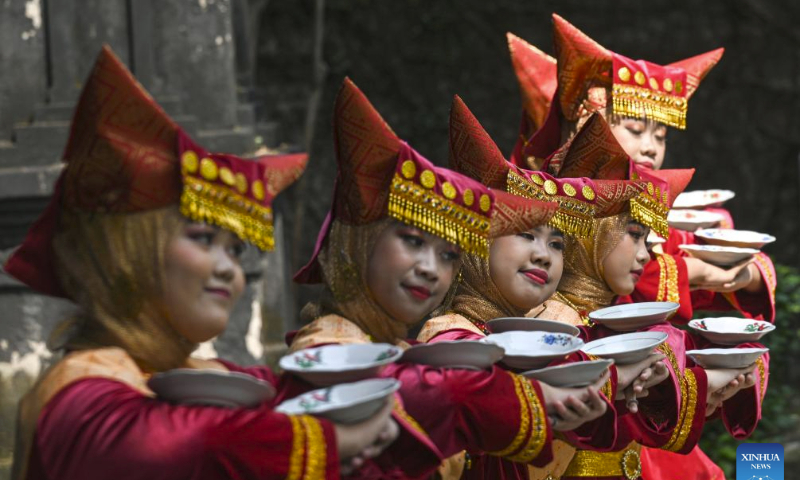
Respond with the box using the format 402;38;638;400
289;79;557;476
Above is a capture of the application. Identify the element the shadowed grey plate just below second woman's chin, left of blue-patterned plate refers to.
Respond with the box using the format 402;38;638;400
401;340;503;370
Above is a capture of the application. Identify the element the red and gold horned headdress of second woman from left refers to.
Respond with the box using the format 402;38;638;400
295;79;558;283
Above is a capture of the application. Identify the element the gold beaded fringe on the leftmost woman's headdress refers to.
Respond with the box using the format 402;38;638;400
181;175;275;250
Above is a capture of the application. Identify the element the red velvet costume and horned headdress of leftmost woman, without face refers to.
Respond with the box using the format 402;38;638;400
5;47;350;480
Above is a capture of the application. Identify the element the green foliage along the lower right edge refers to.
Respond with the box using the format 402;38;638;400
700;265;800;478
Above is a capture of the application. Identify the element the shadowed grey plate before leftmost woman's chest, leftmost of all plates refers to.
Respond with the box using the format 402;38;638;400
147;368;275;408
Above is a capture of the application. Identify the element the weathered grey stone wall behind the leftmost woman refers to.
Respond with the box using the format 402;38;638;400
0;0;294;480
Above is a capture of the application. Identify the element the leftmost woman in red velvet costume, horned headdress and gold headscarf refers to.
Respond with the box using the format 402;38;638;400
5;47;397;480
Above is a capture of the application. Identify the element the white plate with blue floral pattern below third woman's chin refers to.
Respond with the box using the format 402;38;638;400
482;332;583;370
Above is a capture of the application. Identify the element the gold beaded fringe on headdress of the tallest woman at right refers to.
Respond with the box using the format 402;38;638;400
611;83;689;130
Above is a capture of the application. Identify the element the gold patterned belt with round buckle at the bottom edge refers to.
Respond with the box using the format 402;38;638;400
563;442;642;480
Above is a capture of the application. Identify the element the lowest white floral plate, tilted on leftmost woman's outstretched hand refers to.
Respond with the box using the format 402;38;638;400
275;378;400;423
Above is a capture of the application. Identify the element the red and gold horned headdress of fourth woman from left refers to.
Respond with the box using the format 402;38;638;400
543;114;694;238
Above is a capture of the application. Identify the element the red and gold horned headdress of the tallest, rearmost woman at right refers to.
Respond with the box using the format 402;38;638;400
511;14;724;168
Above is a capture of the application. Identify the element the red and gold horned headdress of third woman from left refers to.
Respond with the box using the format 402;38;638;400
450;96;645;237
